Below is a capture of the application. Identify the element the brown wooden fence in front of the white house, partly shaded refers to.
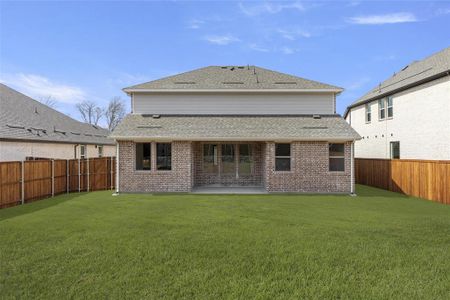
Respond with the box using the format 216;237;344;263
355;158;450;204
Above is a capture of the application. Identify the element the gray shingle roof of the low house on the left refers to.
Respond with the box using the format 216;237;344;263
0;84;115;145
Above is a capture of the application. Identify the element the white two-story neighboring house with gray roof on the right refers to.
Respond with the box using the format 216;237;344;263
344;48;450;160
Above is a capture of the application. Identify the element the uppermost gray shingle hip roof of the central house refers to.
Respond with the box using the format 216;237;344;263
123;66;342;93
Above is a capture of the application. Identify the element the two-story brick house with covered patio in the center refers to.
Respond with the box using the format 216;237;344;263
111;66;359;193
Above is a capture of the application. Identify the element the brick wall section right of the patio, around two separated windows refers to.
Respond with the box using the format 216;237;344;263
265;142;351;193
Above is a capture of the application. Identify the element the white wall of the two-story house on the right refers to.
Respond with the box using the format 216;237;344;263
346;76;450;160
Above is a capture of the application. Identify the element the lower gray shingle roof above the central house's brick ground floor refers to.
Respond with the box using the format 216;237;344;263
111;114;360;141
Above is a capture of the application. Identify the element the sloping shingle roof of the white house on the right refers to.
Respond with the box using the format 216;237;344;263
344;47;450;116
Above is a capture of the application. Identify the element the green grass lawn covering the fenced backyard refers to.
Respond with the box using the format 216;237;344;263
0;186;450;299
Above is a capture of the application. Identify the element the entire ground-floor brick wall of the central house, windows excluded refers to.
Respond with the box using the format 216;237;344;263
119;141;351;193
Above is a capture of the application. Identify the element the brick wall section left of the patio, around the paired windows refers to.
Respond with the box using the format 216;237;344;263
119;141;193;193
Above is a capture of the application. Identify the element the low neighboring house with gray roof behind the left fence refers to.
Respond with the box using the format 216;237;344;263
0;84;116;161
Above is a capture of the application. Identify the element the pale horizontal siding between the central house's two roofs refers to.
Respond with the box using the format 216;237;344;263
132;93;335;115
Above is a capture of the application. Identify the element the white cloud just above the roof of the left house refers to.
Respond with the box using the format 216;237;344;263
0;73;86;104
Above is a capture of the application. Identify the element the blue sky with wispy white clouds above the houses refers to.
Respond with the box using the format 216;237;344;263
0;1;450;124
